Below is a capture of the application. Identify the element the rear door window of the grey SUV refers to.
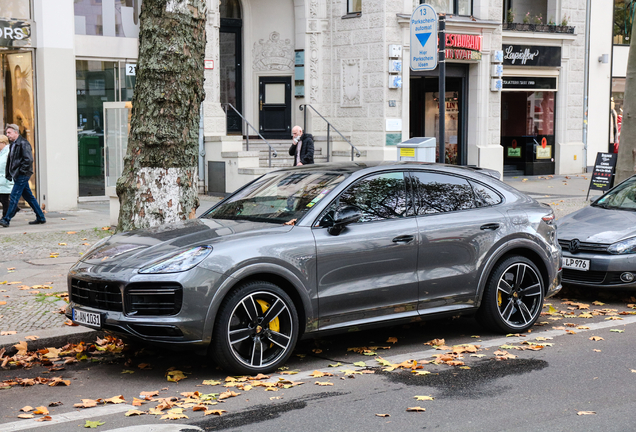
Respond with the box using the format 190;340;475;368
411;172;477;215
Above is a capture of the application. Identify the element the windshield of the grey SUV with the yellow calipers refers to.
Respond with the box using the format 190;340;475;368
203;171;347;225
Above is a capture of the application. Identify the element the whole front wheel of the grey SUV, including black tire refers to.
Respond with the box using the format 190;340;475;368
211;281;299;375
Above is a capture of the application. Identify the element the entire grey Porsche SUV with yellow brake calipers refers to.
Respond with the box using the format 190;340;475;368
67;162;561;374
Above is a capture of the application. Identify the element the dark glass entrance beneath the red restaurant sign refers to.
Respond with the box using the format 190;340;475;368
409;64;468;165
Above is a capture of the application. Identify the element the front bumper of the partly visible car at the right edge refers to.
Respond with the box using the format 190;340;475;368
563;252;636;290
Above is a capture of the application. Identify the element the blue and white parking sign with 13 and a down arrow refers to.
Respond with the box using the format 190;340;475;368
409;4;437;71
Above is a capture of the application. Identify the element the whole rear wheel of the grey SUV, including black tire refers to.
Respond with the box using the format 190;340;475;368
477;255;545;333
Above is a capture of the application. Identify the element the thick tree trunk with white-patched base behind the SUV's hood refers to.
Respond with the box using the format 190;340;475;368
117;0;206;231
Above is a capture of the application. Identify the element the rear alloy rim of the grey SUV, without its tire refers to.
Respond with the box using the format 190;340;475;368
497;263;543;328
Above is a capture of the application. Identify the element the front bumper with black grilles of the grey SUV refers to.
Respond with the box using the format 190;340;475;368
66;266;221;348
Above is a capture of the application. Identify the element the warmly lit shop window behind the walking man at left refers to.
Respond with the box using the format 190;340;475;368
0;50;37;196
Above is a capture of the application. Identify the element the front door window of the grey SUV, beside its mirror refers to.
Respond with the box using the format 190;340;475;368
331;172;406;223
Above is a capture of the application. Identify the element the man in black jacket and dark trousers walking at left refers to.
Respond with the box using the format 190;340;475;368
0;124;46;228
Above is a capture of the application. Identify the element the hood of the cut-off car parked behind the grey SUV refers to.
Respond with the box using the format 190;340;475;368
557;206;636;243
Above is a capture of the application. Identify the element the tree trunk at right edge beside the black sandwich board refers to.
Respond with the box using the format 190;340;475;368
610;14;636;185
